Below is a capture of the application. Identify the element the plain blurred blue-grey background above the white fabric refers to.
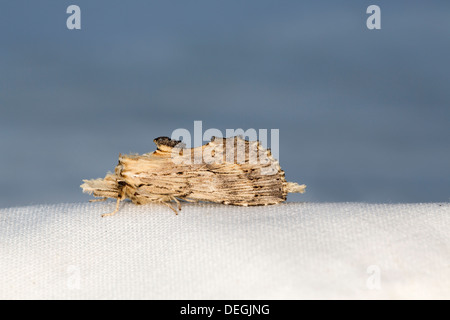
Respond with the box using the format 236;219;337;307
0;0;450;207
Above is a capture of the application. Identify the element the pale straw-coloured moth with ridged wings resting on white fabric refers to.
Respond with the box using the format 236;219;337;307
81;136;306;217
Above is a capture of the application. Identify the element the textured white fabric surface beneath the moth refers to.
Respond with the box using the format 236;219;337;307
0;202;450;299
